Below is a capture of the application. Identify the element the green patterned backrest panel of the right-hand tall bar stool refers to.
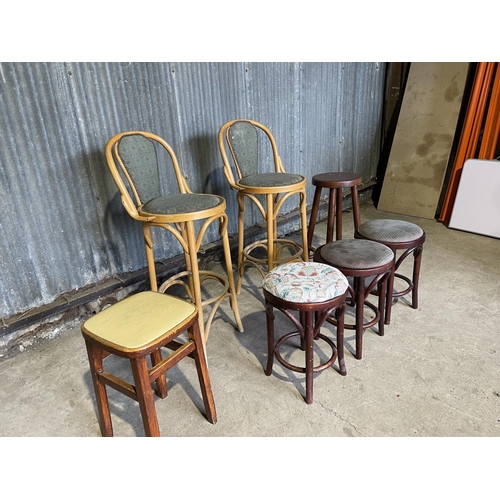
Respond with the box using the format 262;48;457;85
227;121;259;177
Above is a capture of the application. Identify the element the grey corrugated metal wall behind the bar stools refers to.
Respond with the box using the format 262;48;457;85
0;62;385;318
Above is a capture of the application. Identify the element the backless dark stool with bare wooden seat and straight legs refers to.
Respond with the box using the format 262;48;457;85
307;172;362;250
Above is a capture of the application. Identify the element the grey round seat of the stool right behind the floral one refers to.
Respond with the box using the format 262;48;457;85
320;240;394;270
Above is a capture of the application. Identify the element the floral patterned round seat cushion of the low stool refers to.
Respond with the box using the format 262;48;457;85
262;262;348;303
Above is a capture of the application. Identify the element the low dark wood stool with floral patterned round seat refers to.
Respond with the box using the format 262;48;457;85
262;262;349;404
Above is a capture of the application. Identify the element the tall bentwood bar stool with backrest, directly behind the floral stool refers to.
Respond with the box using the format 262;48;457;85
219;119;309;293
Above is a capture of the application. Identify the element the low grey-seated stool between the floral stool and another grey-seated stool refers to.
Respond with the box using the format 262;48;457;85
314;239;394;359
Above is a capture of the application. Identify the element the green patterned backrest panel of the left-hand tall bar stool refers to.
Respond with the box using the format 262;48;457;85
118;134;161;204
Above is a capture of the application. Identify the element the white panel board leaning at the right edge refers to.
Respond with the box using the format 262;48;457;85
448;159;500;238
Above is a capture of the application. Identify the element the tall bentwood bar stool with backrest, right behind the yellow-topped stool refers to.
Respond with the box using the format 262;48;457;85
106;131;243;341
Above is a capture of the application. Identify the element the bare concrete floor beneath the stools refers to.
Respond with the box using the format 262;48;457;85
0;203;500;437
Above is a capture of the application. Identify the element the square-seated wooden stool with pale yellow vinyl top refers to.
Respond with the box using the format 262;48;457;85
82;291;217;437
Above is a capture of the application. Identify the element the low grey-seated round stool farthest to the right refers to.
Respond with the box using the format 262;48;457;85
354;219;425;325
